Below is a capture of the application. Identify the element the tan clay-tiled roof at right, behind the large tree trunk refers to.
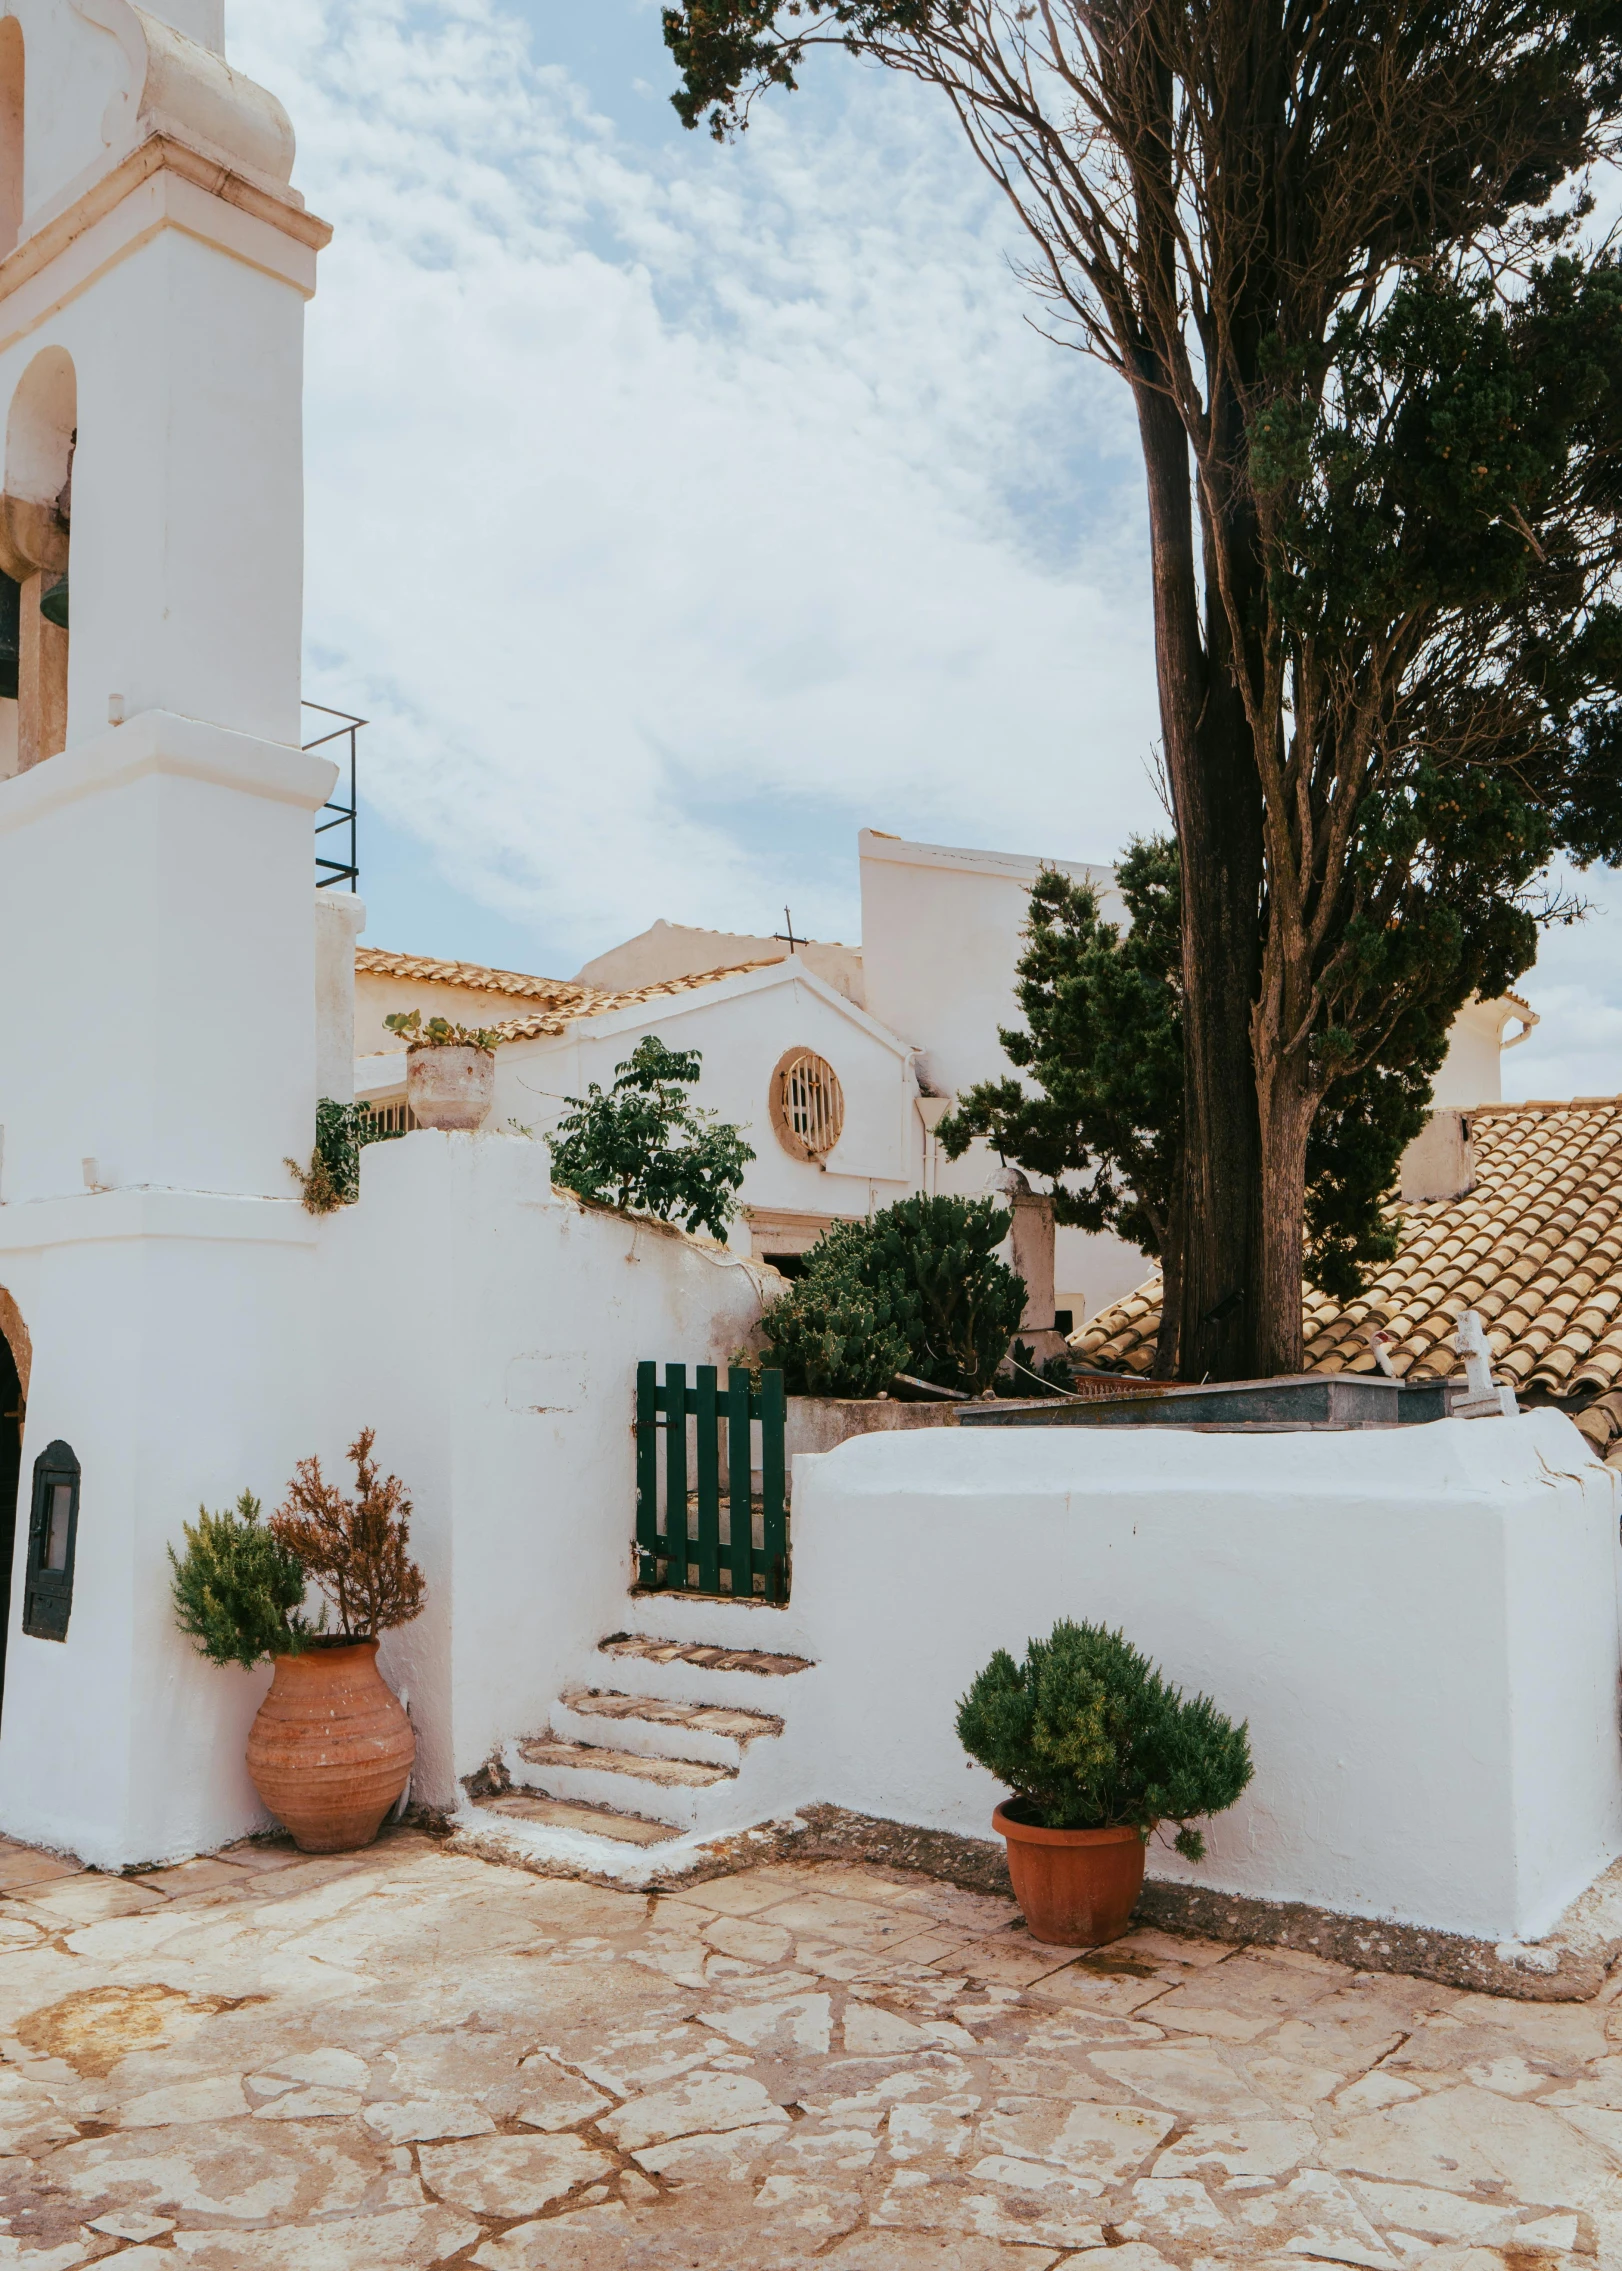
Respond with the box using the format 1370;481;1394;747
1070;1097;1622;1467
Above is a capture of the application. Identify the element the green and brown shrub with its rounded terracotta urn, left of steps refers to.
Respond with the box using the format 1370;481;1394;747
170;1428;425;1853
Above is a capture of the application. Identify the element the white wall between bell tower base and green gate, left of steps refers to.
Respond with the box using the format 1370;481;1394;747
318;1129;766;1805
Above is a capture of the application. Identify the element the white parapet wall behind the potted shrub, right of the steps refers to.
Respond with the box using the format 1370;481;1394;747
793;1413;1622;1939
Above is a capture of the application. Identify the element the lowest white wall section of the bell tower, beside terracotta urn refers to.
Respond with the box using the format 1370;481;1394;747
0;1190;318;1869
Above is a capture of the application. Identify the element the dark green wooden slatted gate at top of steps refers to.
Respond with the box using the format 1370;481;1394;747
636;1365;788;1601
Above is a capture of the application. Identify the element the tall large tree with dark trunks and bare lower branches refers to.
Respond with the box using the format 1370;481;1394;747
666;0;1622;1378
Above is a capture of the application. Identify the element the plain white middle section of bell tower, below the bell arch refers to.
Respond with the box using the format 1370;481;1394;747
0;717;334;1201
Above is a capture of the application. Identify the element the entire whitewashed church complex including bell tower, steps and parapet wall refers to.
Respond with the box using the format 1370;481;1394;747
0;0;1622;1980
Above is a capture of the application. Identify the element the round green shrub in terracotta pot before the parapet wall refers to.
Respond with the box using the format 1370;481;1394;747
956;1619;1252;1949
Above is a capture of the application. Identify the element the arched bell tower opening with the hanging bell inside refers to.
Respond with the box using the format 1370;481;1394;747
0;347;80;772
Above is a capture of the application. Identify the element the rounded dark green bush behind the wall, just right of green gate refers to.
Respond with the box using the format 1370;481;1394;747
761;1195;1025;1397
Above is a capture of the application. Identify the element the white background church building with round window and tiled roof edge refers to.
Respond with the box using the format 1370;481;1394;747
347;829;1538;1333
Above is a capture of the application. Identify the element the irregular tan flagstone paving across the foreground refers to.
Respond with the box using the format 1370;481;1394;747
0;1830;1622;2271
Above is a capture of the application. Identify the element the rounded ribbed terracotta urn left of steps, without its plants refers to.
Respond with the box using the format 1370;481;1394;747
248;1640;416;1853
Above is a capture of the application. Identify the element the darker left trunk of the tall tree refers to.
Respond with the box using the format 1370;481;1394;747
1136;384;1263;1381
